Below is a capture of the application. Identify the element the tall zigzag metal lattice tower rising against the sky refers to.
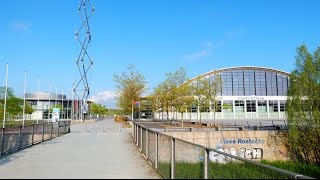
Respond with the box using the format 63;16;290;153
73;0;94;119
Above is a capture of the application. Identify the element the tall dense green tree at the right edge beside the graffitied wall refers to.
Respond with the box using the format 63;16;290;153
281;44;320;163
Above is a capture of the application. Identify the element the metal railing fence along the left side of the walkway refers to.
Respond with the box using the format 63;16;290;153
0;121;70;156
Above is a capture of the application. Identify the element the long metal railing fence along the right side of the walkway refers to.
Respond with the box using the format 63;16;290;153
132;122;313;179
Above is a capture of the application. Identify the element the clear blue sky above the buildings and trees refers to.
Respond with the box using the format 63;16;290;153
0;0;320;108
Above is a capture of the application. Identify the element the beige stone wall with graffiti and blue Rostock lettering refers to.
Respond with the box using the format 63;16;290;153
159;131;287;160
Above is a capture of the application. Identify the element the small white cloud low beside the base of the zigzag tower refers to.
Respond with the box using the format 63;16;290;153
90;91;117;108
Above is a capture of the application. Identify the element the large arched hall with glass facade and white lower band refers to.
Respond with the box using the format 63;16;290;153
159;66;289;120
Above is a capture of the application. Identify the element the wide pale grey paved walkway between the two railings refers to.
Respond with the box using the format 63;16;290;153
0;119;161;179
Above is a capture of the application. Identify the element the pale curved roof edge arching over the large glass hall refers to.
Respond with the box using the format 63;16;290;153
183;66;290;84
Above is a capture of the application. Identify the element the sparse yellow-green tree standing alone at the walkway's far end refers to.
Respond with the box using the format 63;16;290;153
113;65;146;116
